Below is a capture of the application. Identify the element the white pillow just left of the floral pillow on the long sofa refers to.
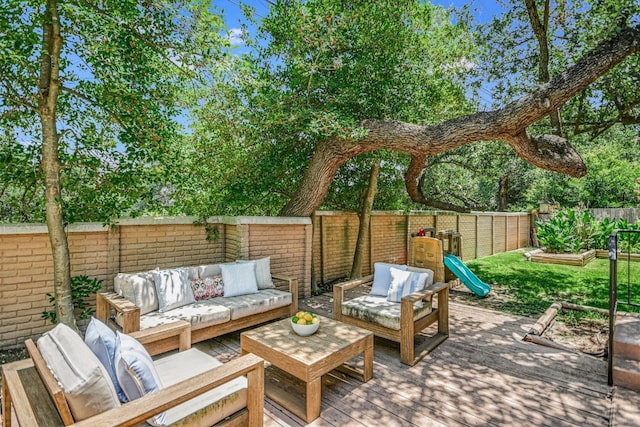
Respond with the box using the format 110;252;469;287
153;268;196;313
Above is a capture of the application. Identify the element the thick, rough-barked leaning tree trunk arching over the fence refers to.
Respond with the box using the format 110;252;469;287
280;27;640;216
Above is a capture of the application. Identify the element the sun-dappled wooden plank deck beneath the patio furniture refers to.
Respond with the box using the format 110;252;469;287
196;295;640;427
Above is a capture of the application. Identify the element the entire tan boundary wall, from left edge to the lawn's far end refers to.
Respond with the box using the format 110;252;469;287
0;212;530;348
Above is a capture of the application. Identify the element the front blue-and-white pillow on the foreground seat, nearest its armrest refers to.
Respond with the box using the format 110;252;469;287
114;331;165;426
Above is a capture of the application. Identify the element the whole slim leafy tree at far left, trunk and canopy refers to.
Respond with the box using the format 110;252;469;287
0;0;226;326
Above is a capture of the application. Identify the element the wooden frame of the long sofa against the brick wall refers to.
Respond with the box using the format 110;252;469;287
95;274;298;355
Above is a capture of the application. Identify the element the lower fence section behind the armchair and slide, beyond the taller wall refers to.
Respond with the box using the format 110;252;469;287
311;211;531;285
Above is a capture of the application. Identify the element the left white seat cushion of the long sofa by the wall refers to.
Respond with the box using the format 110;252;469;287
140;298;231;330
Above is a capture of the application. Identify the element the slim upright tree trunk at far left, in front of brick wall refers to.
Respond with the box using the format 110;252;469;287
38;0;77;330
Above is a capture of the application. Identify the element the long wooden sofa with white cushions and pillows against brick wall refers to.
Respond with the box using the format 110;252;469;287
96;257;298;354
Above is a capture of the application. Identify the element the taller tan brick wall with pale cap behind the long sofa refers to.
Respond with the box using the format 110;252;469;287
0;217;311;349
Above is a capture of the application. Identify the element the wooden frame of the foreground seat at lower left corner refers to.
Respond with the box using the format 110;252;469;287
2;321;264;427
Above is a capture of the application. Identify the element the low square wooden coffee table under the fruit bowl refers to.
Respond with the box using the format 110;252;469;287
240;316;373;422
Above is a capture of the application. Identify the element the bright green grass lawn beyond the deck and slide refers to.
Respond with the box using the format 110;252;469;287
465;249;640;317
